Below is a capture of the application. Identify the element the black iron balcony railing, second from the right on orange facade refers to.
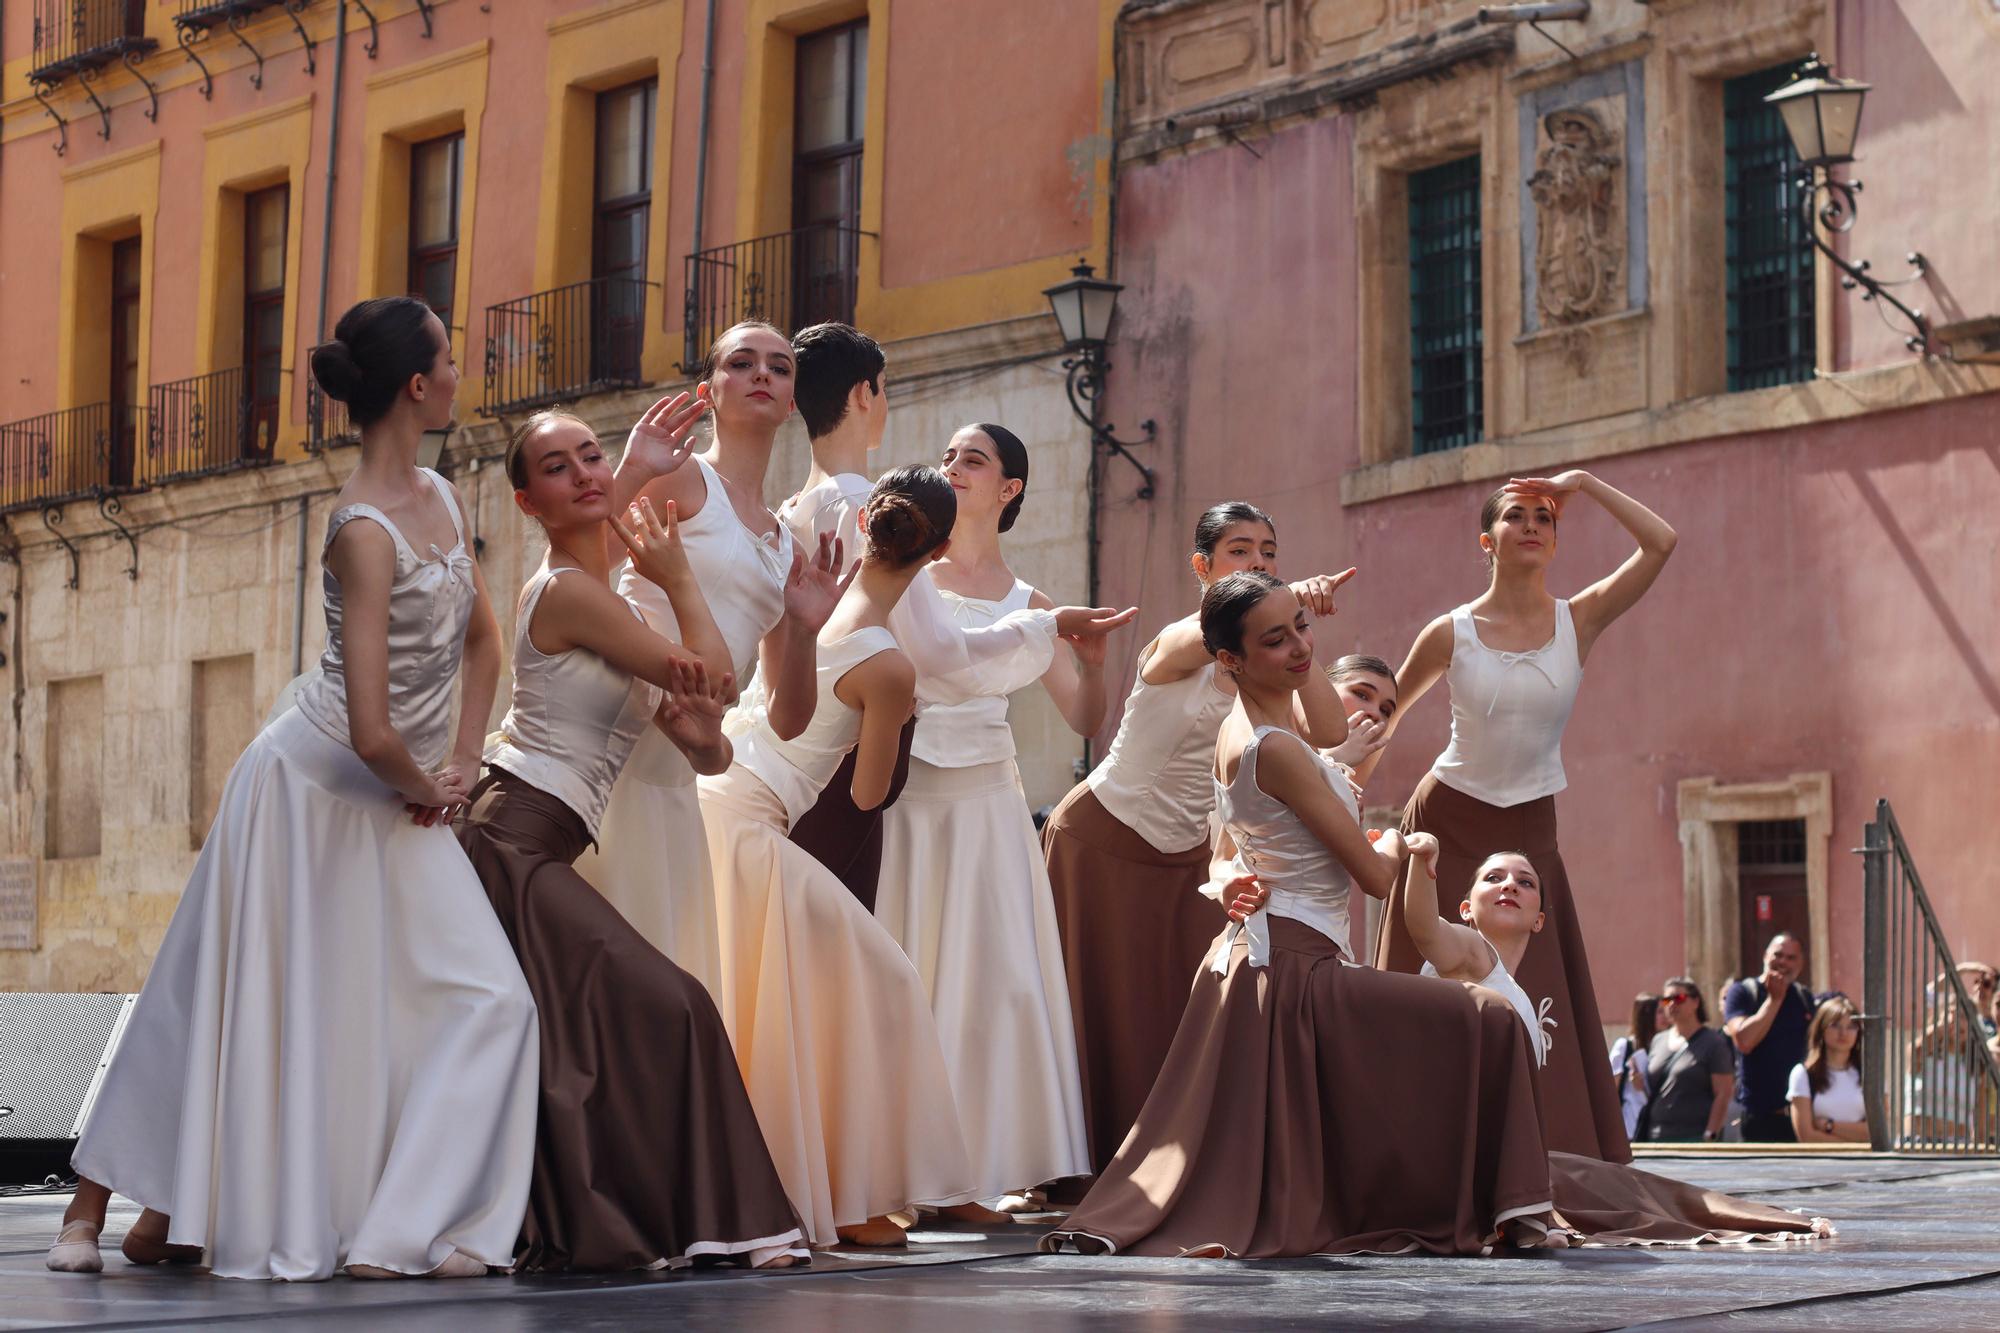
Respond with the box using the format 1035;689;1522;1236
480;278;656;416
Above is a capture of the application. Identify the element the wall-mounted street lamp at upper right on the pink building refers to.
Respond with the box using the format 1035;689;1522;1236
1764;54;1930;356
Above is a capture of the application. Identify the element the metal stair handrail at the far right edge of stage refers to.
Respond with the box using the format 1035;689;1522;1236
1856;799;2000;1153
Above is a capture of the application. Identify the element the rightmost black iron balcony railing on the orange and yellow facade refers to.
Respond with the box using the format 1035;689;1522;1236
682;222;870;370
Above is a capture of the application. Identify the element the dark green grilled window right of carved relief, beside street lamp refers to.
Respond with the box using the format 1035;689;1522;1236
1722;64;1816;392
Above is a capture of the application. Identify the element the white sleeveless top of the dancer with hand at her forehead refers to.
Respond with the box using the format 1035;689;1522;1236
1432;598;1584;809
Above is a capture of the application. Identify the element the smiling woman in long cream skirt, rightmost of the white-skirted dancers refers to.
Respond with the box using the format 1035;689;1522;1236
874;424;1106;1197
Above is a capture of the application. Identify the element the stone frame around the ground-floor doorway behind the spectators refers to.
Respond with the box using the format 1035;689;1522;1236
1678;773;1834;997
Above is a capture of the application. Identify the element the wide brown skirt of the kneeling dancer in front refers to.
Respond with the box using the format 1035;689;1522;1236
1042;917;1552;1259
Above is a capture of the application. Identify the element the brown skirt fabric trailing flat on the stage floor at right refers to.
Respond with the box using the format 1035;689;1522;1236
1548;1153;1834;1245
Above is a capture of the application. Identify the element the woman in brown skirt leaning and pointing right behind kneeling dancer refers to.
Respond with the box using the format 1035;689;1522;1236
1042;500;1352;1171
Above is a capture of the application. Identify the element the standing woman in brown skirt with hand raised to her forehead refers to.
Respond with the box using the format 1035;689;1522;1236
1360;472;1674;1161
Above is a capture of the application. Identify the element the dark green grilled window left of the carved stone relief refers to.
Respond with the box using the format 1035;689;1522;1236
1410;154;1486;454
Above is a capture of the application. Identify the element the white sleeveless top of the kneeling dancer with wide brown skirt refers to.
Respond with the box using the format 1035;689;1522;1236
1212;727;1360;973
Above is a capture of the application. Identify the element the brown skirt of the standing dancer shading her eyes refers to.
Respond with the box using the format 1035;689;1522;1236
1374;773;1632;1163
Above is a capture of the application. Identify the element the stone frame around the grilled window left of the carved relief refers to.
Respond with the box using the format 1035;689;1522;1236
1354;66;1516;466
